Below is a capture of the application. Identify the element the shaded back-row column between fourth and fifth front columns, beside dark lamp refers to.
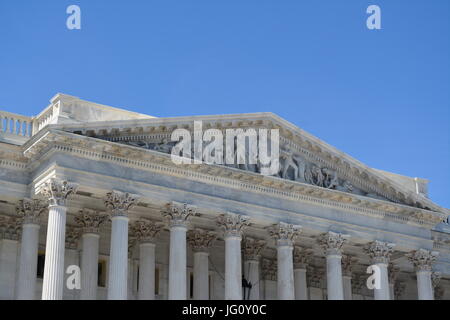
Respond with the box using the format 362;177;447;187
242;237;266;300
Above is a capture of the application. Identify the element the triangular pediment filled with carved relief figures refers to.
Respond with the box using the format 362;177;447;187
28;113;446;212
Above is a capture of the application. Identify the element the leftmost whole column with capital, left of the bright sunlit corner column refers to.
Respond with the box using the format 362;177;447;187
16;199;45;300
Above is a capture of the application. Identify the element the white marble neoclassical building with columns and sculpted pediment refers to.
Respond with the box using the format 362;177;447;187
0;94;450;300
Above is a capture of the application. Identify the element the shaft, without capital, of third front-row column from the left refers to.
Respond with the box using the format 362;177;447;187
169;225;187;300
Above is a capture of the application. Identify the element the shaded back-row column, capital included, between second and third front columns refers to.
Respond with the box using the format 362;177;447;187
131;219;163;300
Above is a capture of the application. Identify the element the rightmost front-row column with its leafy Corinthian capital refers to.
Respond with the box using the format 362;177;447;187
406;249;439;300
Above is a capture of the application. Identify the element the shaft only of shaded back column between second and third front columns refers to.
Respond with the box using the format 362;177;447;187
138;242;156;300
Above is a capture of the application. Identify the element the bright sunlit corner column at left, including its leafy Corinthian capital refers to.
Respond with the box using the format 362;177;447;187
42;178;78;300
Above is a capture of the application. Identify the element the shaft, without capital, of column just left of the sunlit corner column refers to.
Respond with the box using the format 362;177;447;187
16;223;40;300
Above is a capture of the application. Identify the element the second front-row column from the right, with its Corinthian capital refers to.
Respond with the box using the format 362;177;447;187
364;240;395;300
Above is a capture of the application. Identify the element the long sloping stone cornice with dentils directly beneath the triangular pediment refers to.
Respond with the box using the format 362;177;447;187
18;130;445;228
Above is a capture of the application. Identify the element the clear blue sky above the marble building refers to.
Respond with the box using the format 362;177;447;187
0;0;450;208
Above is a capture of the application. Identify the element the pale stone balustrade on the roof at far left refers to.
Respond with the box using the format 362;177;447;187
0;111;33;144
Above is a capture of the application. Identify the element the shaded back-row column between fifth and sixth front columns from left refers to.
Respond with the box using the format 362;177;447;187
294;247;312;300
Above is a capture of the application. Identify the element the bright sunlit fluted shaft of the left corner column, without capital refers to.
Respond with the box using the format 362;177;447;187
42;205;67;300
